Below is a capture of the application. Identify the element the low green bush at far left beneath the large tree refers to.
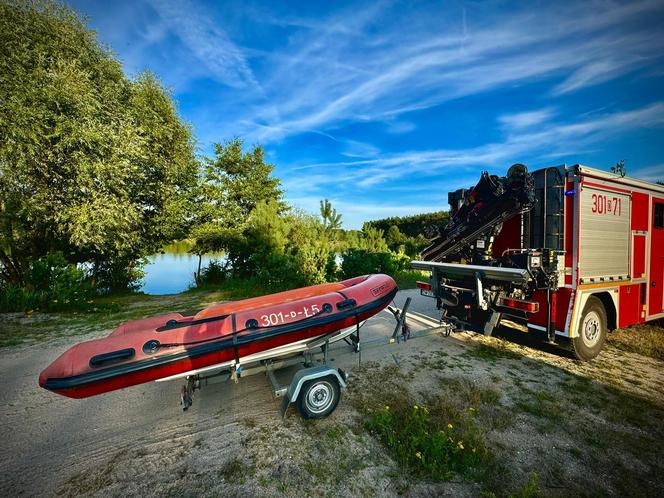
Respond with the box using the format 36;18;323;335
0;252;94;311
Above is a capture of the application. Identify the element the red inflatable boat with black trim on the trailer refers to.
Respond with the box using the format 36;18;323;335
39;275;397;398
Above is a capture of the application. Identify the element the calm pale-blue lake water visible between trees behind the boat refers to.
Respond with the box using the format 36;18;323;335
140;246;223;295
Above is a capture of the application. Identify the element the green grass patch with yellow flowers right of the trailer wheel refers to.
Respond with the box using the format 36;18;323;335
349;366;508;481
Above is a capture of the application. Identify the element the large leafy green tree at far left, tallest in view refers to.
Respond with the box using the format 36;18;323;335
0;0;198;287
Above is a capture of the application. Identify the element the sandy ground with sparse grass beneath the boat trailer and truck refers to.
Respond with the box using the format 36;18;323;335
0;291;664;496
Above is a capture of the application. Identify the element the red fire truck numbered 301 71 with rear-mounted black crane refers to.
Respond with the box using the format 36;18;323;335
412;164;664;360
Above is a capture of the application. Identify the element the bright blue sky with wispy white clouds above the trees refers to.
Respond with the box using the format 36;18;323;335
69;0;664;228
